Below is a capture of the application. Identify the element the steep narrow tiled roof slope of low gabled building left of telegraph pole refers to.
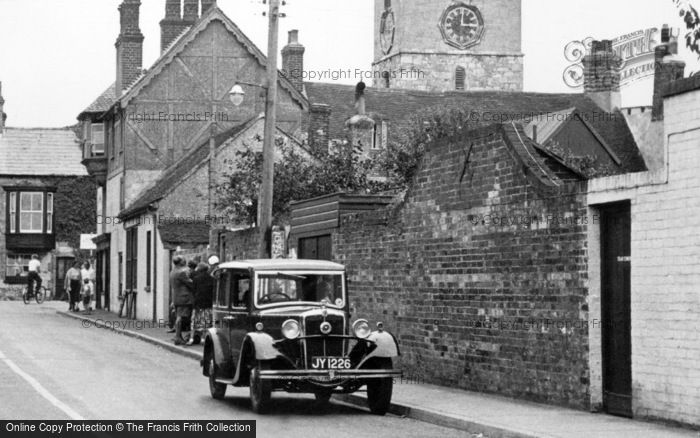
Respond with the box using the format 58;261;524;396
119;117;258;218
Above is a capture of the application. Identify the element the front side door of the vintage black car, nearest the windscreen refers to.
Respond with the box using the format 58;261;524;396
226;270;251;364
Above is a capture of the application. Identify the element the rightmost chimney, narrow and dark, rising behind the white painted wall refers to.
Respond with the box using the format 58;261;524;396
651;24;685;121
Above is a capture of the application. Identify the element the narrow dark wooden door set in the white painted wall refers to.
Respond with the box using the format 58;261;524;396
601;203;632;417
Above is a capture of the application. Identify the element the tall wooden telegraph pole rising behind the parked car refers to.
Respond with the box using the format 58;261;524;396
258;0;280;258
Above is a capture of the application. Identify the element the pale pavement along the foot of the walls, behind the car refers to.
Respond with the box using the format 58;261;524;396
50;302;700;438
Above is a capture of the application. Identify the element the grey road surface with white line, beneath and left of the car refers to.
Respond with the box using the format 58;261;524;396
0;301;468;438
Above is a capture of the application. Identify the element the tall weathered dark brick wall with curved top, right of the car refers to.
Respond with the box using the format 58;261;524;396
333;125;588;408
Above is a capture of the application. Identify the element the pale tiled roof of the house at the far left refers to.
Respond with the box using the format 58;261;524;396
0;128;88;176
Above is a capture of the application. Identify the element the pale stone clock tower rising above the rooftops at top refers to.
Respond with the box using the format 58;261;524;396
372;0;523;91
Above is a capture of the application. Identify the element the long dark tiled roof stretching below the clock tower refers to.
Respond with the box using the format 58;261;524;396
305;82;646;172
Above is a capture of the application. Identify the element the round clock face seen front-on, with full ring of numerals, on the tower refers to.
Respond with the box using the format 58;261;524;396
440;3;484;50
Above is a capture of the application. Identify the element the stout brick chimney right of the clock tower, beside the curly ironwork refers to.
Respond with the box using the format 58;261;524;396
583;40;621;112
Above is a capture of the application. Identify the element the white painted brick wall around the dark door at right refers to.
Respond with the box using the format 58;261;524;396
588;84;700;425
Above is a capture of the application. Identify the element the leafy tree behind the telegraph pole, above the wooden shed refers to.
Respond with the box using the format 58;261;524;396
216;138;387;224
